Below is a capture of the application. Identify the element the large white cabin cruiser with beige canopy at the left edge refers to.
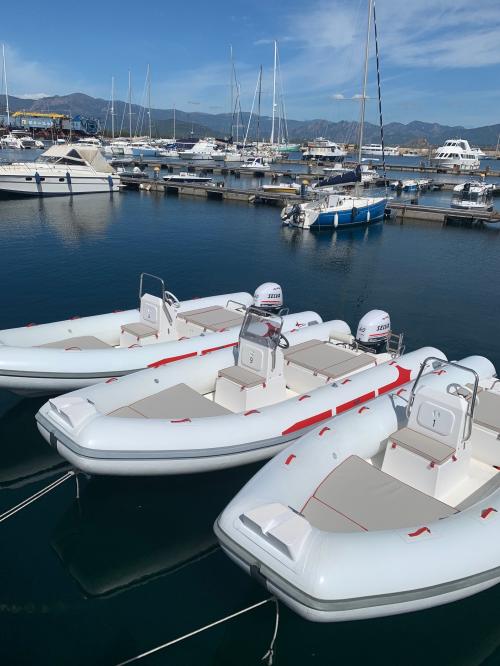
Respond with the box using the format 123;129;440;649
0;144;120;196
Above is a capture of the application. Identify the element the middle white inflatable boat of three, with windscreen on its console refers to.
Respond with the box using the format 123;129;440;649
36;308;416;475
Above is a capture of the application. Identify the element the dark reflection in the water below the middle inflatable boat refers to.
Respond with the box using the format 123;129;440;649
51;465;259;597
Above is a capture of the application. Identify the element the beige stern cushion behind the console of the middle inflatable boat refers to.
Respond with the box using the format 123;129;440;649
284;340;374;379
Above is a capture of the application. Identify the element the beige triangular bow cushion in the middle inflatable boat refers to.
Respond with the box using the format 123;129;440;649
108;384;231;419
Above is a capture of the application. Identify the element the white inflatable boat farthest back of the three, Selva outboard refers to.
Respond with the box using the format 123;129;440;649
0;273;300;395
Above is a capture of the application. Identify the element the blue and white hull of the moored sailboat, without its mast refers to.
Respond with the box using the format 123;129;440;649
281;194;387;231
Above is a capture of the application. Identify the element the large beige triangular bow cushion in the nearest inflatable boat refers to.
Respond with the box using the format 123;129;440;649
301;456;456;532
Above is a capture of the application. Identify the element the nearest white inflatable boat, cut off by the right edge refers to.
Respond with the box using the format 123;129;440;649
215;356;500;622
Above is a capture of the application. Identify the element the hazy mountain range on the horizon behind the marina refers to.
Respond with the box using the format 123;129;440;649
3;93;500;148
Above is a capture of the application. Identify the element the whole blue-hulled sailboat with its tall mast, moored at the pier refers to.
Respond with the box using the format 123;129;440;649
281;0;387;230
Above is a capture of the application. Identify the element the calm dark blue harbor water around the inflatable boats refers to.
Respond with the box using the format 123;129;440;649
0;183;500;666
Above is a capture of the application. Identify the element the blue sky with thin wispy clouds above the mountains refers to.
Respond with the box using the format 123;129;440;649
0;0;500;126
